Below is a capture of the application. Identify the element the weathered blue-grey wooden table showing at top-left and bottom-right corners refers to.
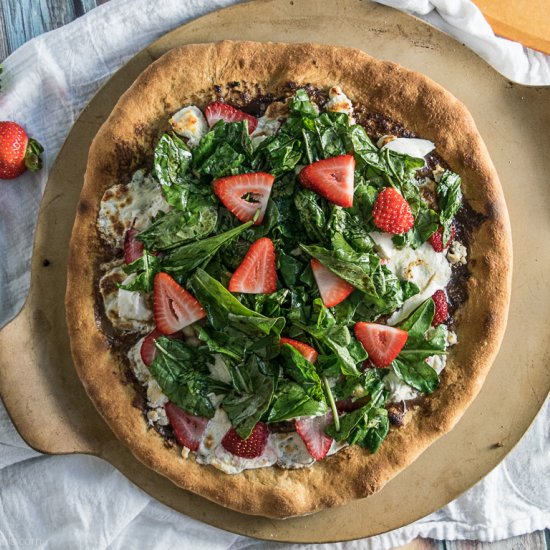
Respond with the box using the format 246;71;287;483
0;0;550;550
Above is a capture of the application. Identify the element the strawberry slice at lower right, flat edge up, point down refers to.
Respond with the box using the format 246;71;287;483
354;322;409;367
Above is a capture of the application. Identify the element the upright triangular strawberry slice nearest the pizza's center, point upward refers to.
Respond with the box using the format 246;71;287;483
228;237;277;294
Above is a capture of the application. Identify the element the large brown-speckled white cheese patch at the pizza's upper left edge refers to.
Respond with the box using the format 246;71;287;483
97;170;170;248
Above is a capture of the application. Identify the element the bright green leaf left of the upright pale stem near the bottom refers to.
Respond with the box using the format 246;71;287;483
267;382;328;422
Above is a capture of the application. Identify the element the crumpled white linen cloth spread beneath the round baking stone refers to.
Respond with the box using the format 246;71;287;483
0;0;550;549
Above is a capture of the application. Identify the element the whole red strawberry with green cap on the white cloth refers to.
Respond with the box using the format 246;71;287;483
0;121;44;180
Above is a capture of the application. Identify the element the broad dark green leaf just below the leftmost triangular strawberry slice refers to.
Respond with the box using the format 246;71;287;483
149;336;224;418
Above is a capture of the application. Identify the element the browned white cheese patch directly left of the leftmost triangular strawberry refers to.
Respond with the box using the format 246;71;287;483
99;261;153;332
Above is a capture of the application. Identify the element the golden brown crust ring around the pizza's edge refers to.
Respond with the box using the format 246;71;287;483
66;41;512;518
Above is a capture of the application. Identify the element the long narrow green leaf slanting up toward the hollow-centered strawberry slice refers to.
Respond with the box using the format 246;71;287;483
162;221;253;279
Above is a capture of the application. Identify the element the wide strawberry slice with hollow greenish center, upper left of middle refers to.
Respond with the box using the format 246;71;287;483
214;172;275;225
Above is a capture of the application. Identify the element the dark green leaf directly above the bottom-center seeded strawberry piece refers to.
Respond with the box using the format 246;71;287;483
223;355;275;439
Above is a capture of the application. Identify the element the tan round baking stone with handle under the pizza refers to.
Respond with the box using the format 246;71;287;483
0;0;550;542
